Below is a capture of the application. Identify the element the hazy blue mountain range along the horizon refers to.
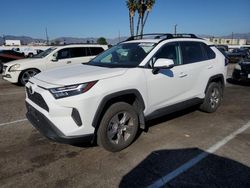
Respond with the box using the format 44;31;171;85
0;33;250;45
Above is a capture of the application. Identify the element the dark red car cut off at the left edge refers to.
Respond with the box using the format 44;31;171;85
0;50;25;73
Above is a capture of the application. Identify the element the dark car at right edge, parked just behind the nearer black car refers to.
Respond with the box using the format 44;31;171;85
227;48;249;63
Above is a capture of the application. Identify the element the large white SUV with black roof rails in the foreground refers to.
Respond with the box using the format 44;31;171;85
26;34;227;152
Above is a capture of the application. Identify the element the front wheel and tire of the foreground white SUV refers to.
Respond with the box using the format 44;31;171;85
97;102;139;152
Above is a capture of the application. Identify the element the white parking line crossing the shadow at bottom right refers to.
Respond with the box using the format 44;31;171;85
148;122;250;188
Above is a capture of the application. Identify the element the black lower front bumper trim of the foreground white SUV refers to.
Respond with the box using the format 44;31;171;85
26;102;94;144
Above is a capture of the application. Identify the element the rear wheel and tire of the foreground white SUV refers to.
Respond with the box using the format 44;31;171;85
200;82;223;113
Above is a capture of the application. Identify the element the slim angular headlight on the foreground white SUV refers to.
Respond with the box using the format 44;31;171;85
49;81;97;99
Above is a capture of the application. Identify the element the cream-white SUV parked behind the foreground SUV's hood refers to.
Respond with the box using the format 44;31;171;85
2;44;108;85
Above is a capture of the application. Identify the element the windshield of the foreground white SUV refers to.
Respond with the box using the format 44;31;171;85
88;42;156;67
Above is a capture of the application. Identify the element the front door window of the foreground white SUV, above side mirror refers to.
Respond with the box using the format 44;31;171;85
155;43;180;64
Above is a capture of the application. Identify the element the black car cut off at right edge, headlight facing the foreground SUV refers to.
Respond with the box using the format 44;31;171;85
232;58;250;82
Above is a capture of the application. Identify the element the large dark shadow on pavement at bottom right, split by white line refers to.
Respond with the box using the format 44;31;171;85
119;148;250;188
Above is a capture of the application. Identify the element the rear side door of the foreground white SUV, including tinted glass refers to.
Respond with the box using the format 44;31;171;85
180;41;215;98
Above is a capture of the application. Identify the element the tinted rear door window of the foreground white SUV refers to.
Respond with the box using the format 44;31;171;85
181;42;207;64
